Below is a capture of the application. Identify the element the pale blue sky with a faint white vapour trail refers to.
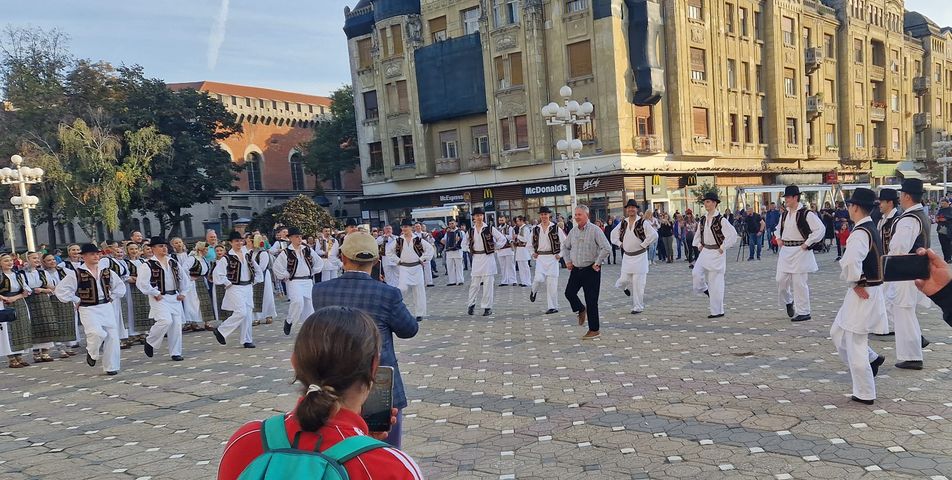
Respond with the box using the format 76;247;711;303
0;0;952;95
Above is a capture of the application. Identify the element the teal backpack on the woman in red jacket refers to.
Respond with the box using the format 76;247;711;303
238;415;389;480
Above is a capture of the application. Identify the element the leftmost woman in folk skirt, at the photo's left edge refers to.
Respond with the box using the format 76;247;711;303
0;253;33;368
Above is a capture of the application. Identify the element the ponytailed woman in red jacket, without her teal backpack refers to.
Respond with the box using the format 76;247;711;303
218;307;423;480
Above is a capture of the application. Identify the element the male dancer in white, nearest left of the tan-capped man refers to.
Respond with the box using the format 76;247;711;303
274;227;324;335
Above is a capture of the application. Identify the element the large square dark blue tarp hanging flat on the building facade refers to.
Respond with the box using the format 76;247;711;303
414;32;486;123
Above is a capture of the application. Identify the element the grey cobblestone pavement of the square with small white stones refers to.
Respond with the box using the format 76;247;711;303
0;248;952;480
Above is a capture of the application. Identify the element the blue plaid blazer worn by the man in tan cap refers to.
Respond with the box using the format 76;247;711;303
311;272;420;409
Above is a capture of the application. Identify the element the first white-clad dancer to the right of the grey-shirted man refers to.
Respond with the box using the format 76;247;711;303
611;199;658;315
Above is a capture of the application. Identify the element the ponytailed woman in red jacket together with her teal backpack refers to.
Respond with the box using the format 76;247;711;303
218;307;423;480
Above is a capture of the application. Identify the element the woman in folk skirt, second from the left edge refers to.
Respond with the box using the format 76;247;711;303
19;252;59;362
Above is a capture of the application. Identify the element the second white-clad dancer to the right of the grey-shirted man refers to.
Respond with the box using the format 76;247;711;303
691;192;738;318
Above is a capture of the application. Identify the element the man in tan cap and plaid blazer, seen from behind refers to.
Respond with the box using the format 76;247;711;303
311;232;419;448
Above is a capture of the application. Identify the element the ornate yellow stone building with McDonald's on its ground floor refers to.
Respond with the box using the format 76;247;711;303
344;0;952;221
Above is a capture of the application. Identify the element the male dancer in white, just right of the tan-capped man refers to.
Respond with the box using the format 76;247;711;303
387;219;436;322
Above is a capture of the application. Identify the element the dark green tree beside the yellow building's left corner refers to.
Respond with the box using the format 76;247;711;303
303;85;360;180
